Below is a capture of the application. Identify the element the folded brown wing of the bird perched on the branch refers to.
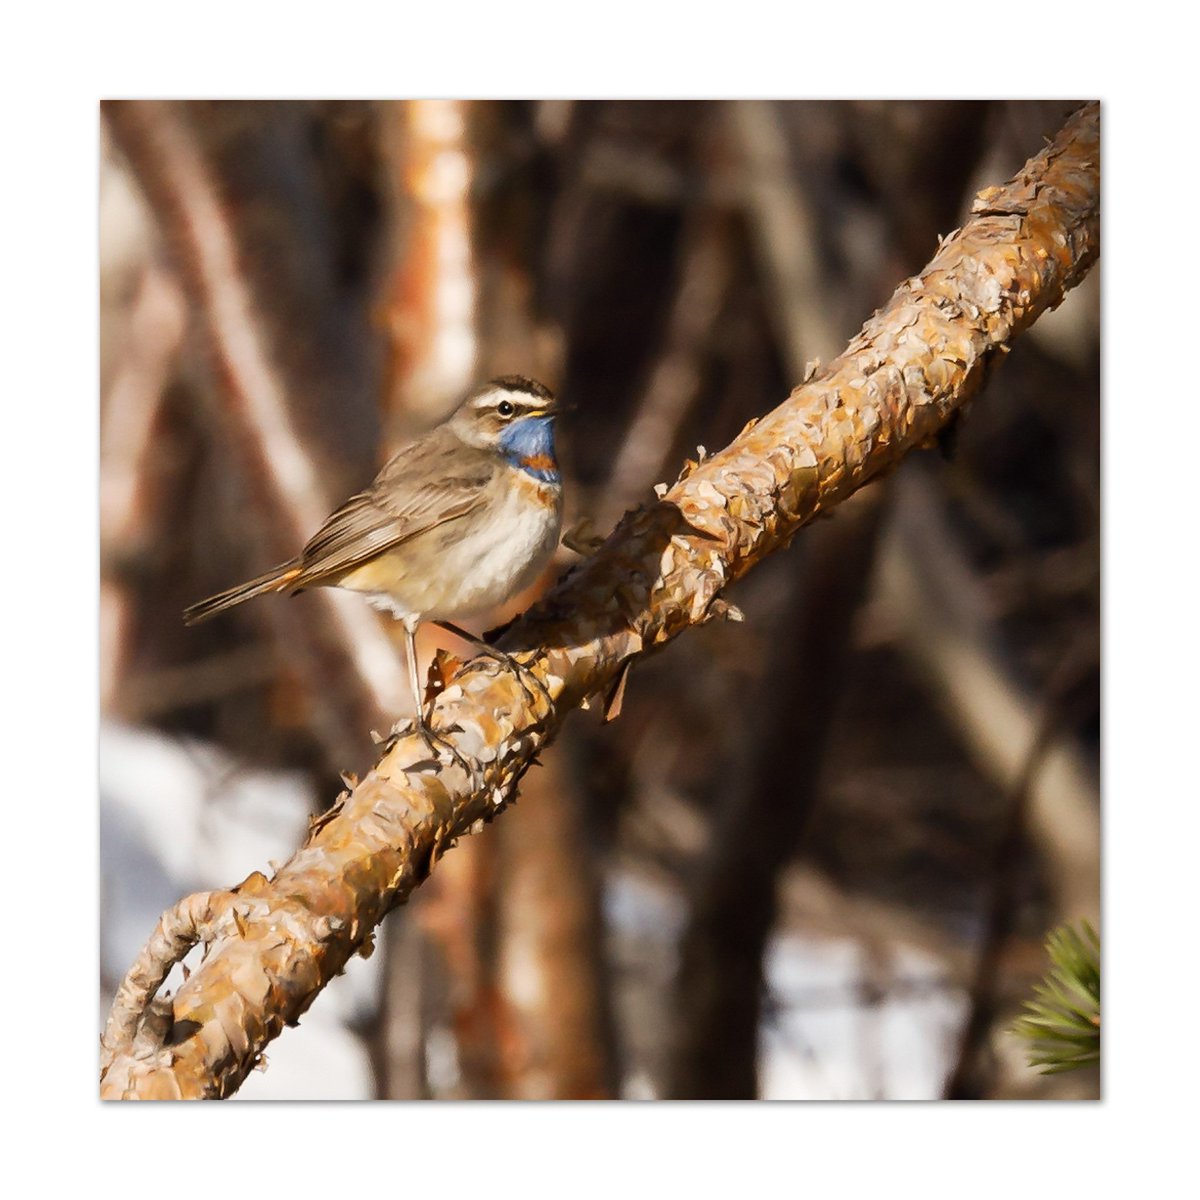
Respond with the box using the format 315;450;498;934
292;428;496;589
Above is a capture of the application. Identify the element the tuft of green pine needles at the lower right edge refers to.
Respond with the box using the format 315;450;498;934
1013;920;1100;1075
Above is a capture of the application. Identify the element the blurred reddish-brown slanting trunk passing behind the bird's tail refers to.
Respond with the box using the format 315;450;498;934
104;101;403;769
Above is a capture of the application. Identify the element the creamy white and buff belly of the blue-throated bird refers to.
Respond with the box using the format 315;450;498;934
343;472;563;620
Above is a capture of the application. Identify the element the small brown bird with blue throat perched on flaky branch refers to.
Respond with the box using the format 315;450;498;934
184;376;563;734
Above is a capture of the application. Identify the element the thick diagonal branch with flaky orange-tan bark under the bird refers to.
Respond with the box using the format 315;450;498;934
101;104;1099;1098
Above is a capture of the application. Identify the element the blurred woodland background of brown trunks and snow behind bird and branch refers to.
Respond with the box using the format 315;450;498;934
100;101;1100;1099
